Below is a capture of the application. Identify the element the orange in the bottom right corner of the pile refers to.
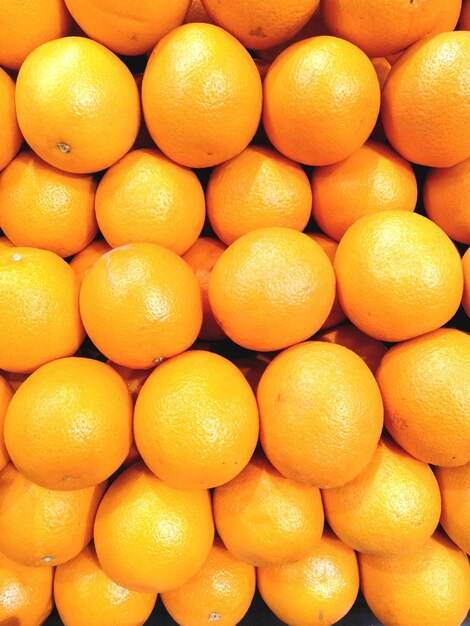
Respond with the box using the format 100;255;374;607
359;533;470;626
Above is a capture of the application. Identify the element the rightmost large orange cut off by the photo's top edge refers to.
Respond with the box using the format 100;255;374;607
322;0;449;57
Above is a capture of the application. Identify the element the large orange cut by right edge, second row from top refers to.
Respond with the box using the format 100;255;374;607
382;31;470;167
